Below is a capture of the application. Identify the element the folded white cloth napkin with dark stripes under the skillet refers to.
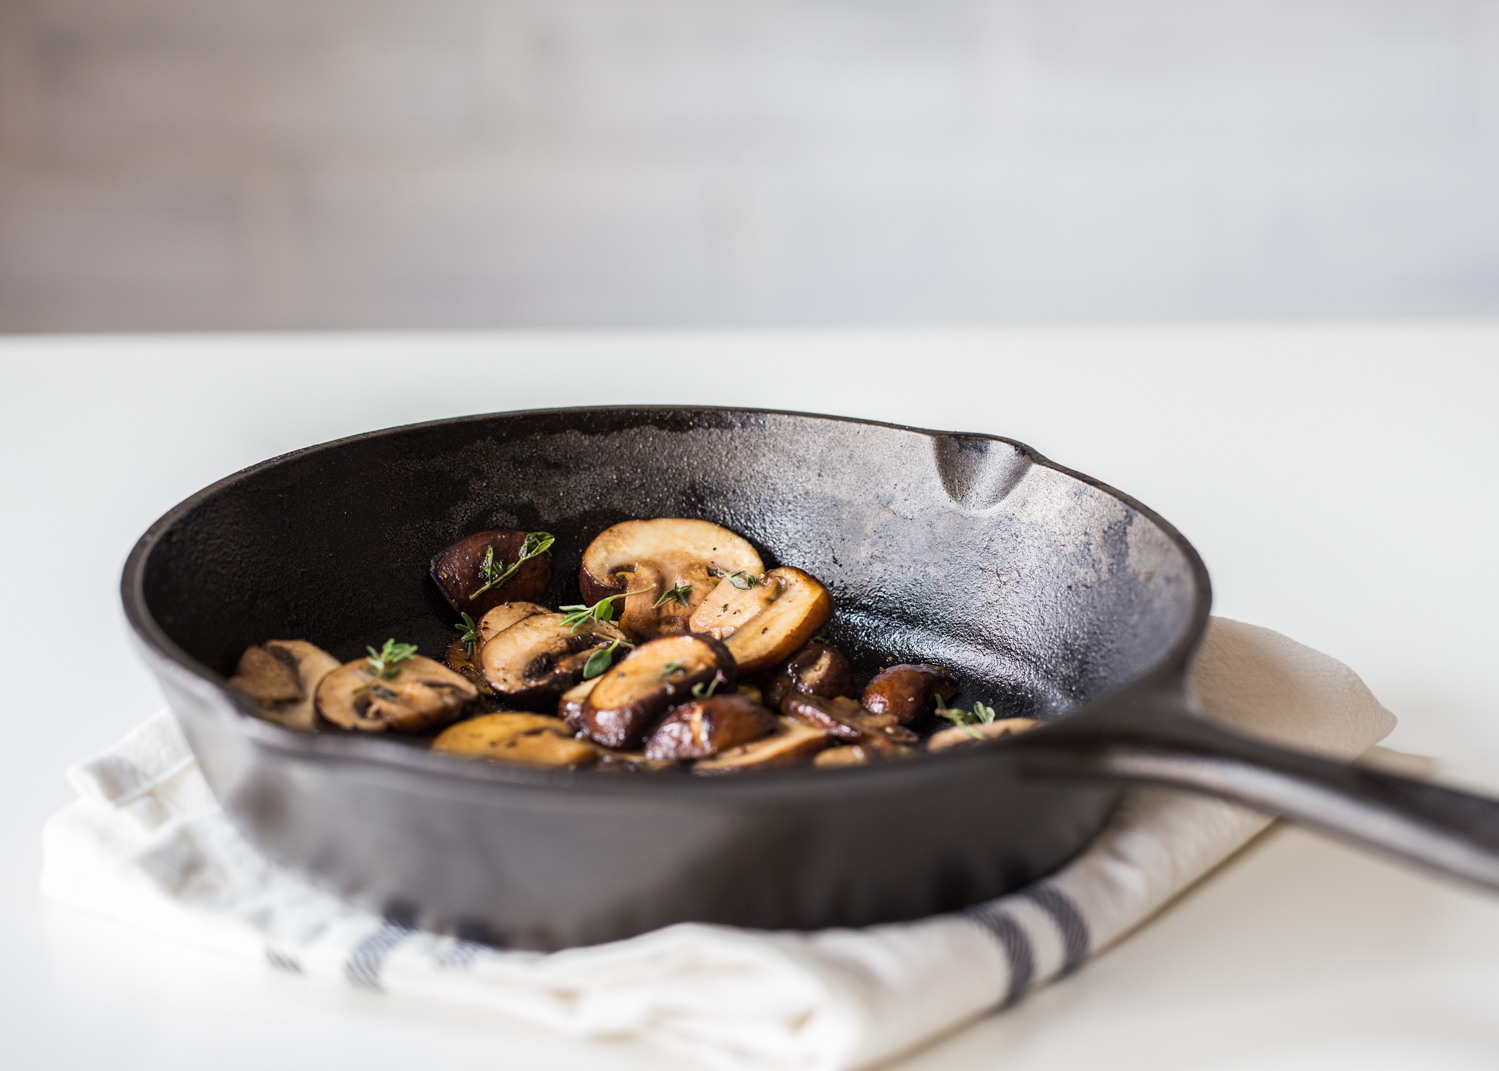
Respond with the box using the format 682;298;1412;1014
42;618;1394;1071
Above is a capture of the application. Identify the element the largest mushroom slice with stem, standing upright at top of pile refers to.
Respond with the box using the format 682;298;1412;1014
577;518;764;641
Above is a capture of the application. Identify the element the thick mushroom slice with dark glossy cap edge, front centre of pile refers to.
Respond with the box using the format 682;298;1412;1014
583;636;735;749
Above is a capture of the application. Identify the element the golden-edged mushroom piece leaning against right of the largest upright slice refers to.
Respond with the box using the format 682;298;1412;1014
690;566;833;674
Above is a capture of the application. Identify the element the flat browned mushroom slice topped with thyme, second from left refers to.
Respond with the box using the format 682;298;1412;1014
318;654;478;732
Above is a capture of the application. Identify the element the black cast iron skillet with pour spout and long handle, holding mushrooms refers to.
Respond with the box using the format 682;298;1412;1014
121;408;1499;948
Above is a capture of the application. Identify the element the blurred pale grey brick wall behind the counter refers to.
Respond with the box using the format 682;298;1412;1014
0;0;1499;330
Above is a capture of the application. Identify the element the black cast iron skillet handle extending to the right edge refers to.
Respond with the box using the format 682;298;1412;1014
1010;696;1499;891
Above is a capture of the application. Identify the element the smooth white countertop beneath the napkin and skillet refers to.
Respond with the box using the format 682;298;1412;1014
0;323;1499;1071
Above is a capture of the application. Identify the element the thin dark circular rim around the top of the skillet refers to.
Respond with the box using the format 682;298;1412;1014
120;405;1213;795
